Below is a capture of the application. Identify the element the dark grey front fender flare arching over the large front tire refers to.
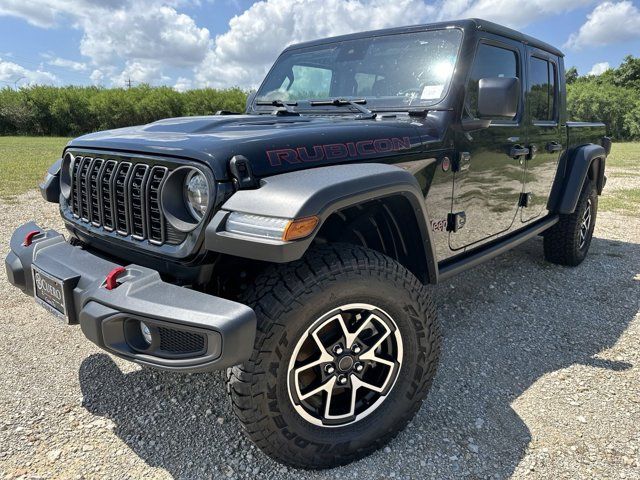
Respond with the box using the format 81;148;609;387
205;160;437;283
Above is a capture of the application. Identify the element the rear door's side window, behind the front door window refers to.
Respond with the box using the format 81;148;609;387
527;57;557;121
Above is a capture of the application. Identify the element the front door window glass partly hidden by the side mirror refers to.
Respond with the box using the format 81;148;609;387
466;43;520;118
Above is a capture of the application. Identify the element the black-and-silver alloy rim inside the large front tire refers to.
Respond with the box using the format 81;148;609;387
288;303;402;427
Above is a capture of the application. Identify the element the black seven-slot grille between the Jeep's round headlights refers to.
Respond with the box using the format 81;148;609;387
69;156;178;245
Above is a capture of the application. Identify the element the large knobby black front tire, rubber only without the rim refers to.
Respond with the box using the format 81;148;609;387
227;244;440;468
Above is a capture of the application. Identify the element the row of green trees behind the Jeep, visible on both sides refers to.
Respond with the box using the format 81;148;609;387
0;55;640;141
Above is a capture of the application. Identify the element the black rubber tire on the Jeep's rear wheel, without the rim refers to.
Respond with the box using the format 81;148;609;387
544;179;598;267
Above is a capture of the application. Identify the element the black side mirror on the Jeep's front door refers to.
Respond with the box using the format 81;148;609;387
478;77;520;120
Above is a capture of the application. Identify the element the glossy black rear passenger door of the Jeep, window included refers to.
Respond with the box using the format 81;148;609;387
521;47;563;222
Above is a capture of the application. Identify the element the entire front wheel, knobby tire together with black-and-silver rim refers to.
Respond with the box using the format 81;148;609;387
228;245;440;468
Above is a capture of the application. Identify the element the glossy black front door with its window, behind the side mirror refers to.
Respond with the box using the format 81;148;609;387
449;38;526;250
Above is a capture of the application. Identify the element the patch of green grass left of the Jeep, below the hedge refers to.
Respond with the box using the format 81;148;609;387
0;137;69;200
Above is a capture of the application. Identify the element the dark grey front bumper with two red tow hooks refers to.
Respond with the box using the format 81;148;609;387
5;222;256;372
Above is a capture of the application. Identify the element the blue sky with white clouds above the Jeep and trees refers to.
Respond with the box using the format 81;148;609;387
0;0;640;91
